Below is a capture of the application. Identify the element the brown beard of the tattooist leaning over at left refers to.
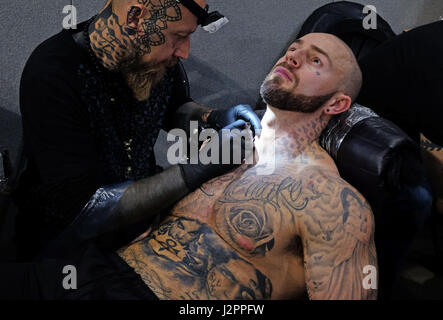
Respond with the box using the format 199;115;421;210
118;55;178;101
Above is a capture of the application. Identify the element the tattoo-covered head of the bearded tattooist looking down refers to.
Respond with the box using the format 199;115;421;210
92;0;206;101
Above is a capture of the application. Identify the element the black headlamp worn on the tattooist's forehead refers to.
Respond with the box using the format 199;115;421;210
176;0;229;33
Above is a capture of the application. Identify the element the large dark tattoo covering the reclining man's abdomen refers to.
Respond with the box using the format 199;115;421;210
121;217;272;299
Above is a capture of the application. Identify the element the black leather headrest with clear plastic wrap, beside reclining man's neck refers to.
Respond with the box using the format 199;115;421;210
320;105;423;206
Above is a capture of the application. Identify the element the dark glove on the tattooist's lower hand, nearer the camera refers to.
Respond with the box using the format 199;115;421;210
179;120;253;191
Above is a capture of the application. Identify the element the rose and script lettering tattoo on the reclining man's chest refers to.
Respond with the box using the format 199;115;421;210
214;168;321;257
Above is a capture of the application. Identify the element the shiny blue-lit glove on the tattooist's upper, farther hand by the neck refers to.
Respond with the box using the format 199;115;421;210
207;104;261;135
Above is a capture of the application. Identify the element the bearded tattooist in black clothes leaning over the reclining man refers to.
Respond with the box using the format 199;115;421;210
14;0;261;261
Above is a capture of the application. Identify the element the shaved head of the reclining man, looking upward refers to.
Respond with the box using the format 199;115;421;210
260;33;362;114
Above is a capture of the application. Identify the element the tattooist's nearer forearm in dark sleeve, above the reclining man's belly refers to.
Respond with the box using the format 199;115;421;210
45;166;189;257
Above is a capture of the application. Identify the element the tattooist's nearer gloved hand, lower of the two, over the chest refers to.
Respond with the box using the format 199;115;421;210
179;120;253;191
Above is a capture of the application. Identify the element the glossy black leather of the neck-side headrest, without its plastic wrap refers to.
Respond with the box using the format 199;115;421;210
336;117;421;203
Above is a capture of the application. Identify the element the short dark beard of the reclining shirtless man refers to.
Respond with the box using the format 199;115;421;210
260;65;335;113
